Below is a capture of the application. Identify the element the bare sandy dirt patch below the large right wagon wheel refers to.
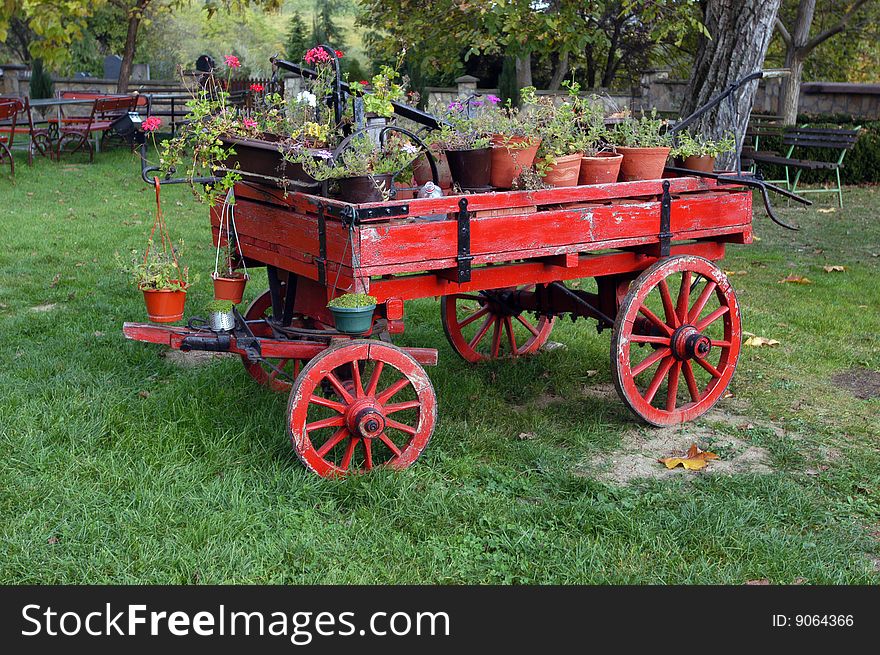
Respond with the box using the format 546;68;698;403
575;410;781;485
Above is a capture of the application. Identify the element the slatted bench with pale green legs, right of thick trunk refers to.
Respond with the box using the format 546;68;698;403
749;125;861;207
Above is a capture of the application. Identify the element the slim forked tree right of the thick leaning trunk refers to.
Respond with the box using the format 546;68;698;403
776;0;877;125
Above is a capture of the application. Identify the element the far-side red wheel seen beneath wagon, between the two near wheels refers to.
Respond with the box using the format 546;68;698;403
440;285;556;362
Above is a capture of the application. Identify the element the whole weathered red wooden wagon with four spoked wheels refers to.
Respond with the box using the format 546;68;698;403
124;177;764;476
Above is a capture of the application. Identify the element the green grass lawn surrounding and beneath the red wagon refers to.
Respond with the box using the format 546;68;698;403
0;151;880;584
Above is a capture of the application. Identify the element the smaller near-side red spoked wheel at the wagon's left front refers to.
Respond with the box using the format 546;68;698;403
287;339;437;477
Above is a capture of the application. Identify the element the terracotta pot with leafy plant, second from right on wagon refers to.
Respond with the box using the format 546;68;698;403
611;109;672;182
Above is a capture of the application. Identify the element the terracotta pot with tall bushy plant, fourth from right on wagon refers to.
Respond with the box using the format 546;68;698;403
521;84;584;187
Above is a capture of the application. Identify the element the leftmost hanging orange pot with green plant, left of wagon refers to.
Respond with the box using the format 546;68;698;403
123;239;189;323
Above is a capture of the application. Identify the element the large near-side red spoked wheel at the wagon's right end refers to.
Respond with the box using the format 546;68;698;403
611;255;742;426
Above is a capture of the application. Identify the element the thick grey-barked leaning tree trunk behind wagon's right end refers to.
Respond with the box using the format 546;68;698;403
681;0;780;168
